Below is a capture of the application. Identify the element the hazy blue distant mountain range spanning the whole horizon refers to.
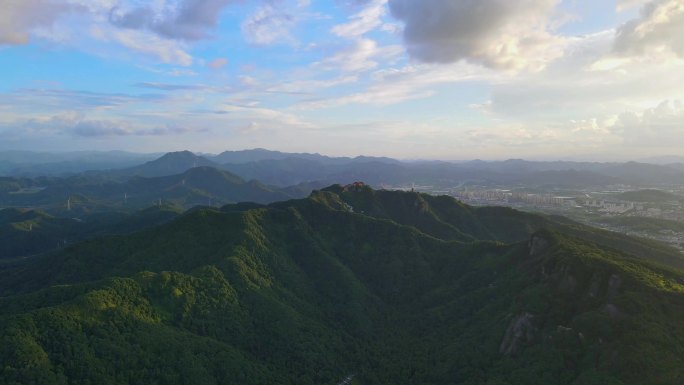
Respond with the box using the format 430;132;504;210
8;149;684;188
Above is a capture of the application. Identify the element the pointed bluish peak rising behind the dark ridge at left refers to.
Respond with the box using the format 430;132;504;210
117;151;220;178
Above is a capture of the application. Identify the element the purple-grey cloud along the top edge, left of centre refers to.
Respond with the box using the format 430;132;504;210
109;0;232;41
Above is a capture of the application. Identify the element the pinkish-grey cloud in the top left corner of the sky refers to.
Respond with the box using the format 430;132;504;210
0;0;83;45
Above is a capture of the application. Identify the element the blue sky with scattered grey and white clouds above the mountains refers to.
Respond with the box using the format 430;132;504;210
0;0;684;160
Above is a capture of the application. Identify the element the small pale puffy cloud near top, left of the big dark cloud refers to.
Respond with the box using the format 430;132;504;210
242;4;295;45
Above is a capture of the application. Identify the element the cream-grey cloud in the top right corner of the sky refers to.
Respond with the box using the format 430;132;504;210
615;0;684;57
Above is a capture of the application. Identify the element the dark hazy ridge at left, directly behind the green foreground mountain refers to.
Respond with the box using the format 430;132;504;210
0;165;302;213
